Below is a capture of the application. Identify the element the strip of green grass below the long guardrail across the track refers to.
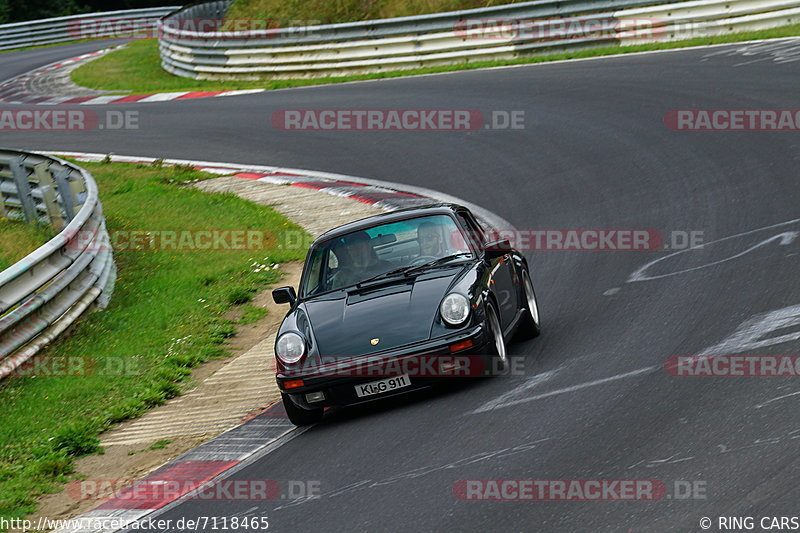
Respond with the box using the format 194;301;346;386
71;24;800;94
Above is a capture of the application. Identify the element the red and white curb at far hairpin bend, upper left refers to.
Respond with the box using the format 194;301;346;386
0;46;266;105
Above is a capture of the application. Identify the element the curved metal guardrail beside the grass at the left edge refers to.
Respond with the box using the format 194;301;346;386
0;149;116;378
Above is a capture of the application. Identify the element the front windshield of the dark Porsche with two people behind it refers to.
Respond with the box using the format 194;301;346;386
302;215;472;296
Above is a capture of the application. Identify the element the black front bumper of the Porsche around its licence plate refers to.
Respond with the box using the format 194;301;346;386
276;325;492;409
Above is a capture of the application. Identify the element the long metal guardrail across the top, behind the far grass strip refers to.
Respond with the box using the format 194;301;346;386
158;0;800;79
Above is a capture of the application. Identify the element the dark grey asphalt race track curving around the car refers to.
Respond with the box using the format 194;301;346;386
0;39;800;532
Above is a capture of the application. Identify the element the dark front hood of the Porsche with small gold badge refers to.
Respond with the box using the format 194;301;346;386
304;265;467;356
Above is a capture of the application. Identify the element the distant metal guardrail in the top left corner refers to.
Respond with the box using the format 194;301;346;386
0;6;180;50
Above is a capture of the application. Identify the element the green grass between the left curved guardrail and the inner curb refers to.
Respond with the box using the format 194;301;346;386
0;163;305;518
